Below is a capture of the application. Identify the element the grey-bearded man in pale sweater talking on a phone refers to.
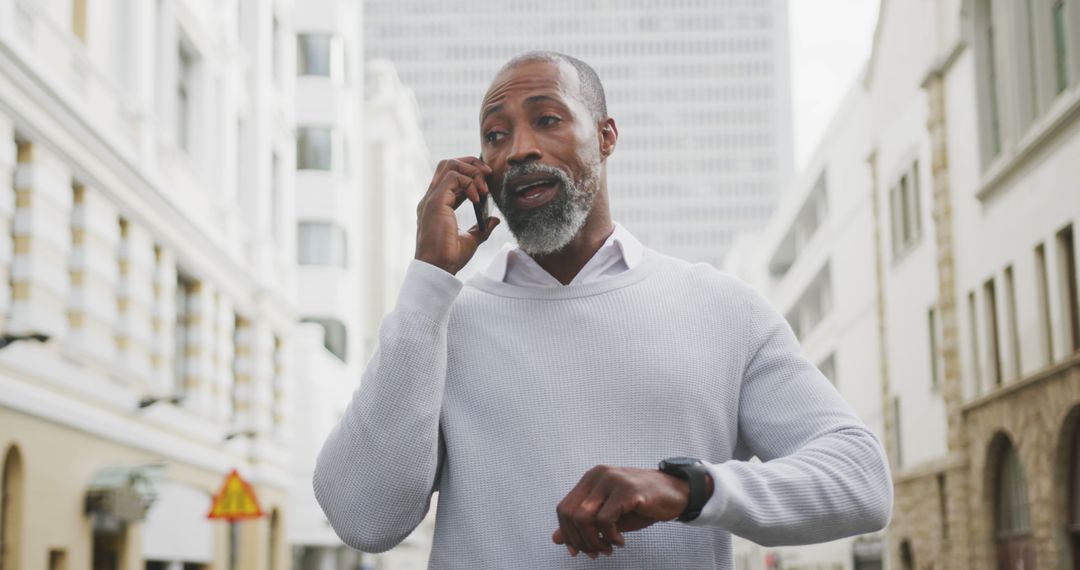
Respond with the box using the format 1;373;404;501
314;52;892;569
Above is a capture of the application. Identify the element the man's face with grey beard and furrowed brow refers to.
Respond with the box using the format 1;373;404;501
481;62;603;255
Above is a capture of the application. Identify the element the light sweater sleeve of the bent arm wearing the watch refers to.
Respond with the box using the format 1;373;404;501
691;285;893;546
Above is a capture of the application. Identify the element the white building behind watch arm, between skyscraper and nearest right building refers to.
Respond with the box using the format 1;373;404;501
725;78;885;570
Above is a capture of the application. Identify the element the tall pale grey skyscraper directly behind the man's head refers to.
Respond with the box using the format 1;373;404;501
364;0;792;264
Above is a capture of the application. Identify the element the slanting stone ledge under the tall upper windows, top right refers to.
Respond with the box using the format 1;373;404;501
975;84;1080;201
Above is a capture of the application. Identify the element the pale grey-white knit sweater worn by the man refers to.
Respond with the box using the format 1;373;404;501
314;249;892;569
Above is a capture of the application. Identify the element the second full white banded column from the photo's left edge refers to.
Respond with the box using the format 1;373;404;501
66;185;120;374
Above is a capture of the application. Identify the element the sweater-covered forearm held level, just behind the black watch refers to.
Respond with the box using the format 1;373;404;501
692;426;892;546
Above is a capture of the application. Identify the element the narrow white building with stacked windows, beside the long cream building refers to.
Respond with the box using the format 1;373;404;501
289;0;366;570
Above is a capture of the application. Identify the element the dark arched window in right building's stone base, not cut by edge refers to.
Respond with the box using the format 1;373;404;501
994;439;1035;570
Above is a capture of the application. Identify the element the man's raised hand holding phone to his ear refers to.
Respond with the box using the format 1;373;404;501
415;157;499;274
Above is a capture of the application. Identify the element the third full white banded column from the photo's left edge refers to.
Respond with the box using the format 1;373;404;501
117;220;154;390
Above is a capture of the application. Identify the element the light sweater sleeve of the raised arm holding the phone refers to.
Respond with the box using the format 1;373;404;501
313;260;463;553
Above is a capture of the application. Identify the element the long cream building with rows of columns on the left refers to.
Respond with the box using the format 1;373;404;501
0;0;296;570
